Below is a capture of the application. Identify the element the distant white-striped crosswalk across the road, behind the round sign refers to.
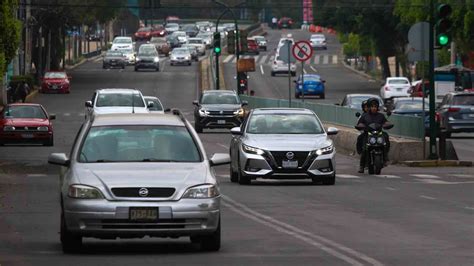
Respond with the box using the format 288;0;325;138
222;54;339;65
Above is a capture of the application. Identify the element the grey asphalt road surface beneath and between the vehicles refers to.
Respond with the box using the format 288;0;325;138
0;28;474;265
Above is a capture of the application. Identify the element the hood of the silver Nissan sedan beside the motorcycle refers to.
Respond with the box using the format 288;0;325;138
243;134;332;151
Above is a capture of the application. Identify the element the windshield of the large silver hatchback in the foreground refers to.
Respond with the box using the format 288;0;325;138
78;125;201;163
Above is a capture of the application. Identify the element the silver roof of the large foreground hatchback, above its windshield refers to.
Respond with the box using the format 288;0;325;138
92;113;185;126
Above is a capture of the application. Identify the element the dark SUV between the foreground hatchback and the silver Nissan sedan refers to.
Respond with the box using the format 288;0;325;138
193;90;247;133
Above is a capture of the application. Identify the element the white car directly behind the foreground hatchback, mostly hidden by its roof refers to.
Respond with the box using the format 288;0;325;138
85;88;148;119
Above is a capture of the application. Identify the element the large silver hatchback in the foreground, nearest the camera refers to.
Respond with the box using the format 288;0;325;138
48;112;230;253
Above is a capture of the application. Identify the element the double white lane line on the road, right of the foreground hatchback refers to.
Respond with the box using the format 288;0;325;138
222;195;383;266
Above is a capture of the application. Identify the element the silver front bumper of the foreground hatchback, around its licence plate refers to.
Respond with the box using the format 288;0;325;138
64;197;220;238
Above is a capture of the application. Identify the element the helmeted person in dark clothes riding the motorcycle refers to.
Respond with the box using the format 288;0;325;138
357;98;390;173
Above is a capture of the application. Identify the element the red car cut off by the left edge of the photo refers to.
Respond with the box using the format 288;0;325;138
0;103;56;146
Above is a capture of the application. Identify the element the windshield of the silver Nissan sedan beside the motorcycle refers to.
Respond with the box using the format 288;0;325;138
247;114;324;134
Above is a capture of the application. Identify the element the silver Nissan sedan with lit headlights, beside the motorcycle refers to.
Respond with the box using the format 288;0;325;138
230;108;338;185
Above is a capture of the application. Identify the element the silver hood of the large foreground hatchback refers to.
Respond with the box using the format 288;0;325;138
74;162;209;195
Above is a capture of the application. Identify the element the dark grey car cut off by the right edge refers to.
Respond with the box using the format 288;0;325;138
436;92;474;137
